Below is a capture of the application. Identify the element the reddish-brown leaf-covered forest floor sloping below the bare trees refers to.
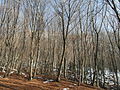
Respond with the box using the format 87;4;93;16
0;73;103;90
